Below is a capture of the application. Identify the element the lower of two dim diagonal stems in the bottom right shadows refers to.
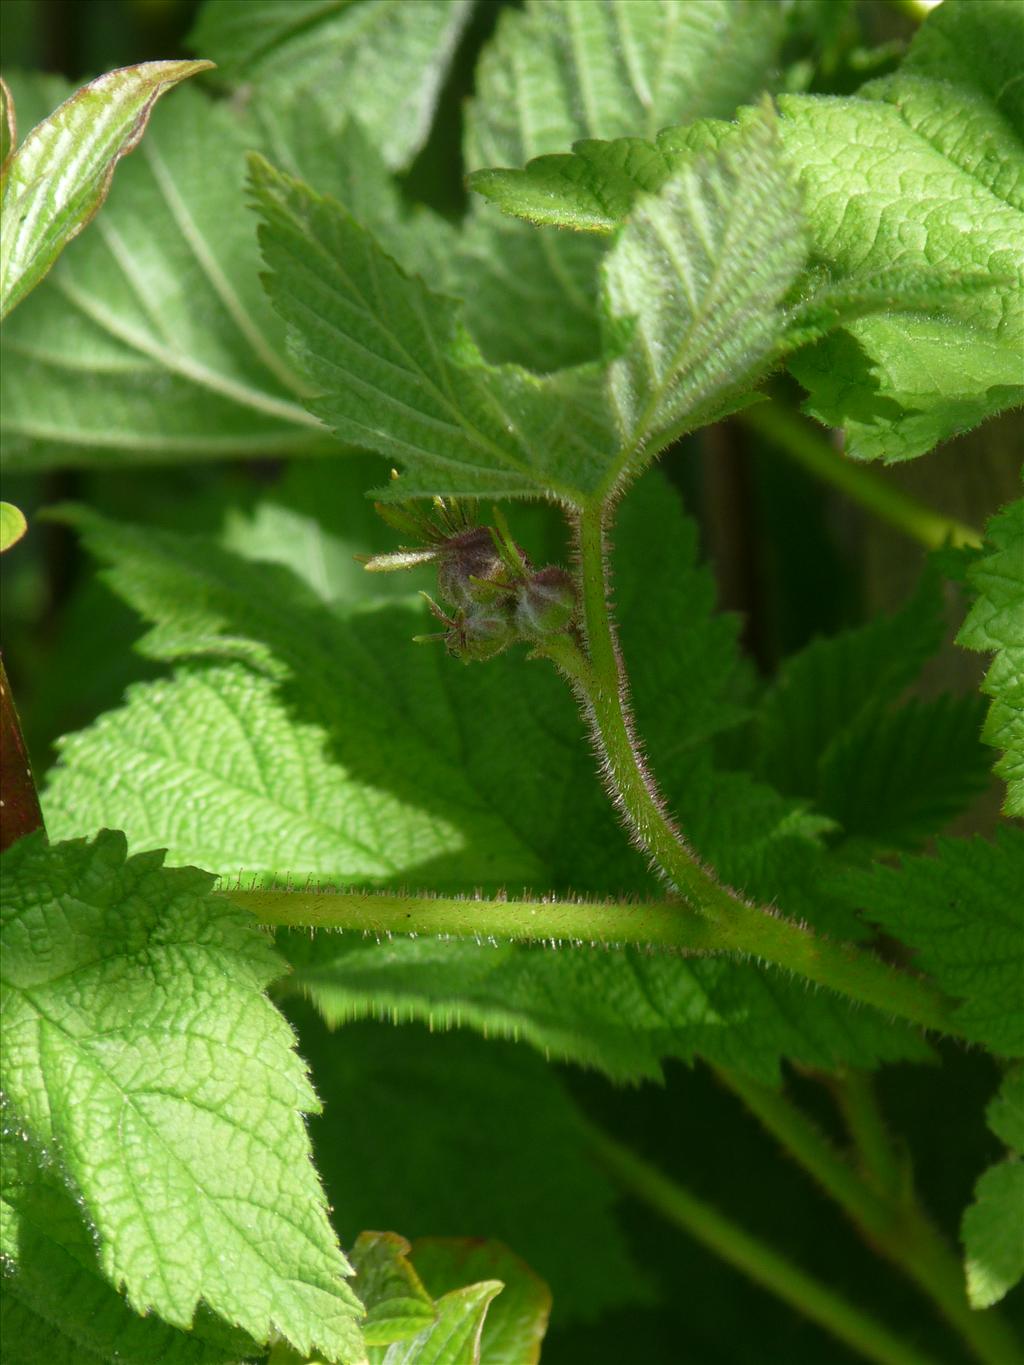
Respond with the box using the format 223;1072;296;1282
590;1132;955;1365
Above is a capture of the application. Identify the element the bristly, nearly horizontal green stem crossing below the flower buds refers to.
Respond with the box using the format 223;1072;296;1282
220;886;958;1033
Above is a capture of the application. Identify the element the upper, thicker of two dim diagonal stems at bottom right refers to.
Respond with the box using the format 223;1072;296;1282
715;1069;1021;1365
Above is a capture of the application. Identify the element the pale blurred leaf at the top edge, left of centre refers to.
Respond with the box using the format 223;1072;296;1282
190;0;472;169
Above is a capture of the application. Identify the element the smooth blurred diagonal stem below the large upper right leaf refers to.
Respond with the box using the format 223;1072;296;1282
739;403;982;550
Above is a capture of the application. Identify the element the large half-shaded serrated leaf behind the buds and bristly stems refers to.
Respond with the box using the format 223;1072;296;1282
46;474;920;1081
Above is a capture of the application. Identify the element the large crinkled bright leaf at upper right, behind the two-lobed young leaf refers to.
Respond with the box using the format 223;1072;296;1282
470;0;1024;460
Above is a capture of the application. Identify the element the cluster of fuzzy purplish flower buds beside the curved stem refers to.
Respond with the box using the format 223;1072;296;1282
363;485;576;663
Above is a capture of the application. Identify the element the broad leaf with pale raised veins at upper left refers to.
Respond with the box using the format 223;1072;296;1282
0;78;333;470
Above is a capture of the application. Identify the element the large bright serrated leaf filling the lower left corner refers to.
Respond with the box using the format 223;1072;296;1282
3;831;362;1361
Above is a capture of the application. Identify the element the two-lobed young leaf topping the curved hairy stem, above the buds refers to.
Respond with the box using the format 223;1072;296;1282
253;111;803;504
